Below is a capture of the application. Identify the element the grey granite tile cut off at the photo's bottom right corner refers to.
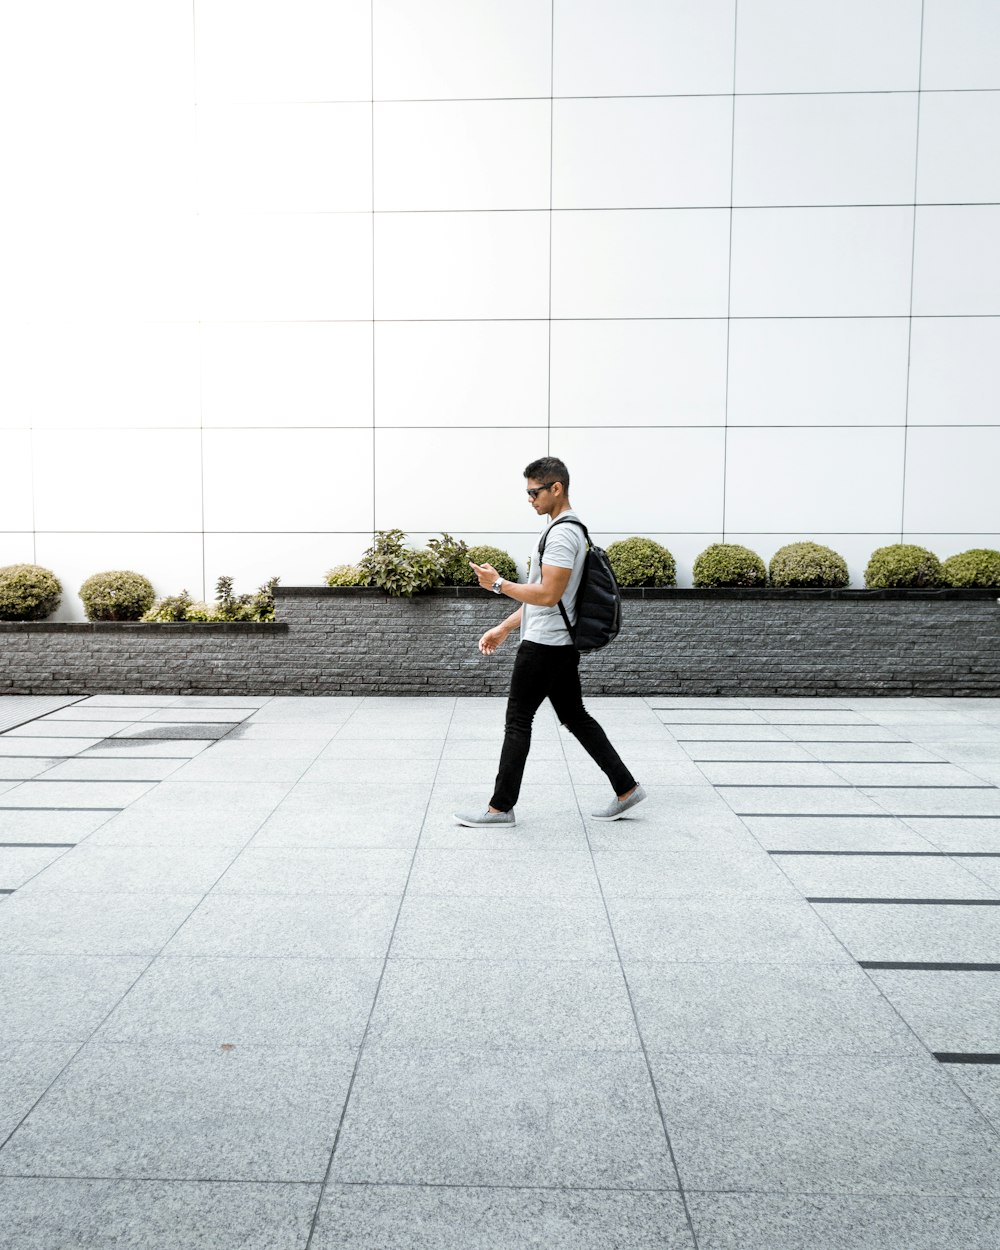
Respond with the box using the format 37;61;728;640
688;1193;1000;1250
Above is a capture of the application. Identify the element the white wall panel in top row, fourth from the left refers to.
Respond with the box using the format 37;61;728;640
555;0;735;95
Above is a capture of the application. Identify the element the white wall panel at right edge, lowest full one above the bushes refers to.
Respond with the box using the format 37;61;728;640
904;425;1000;535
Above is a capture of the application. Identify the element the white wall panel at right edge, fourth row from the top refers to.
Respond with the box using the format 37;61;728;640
909;316;1000;425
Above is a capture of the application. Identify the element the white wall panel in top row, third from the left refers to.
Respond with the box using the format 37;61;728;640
375;0;551;100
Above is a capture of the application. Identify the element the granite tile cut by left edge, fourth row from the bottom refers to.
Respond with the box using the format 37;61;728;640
0;890;201;955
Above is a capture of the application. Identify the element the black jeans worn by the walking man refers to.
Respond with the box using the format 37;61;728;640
490;643;635;811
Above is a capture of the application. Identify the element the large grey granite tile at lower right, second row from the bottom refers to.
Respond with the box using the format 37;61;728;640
650;1051;1000;1198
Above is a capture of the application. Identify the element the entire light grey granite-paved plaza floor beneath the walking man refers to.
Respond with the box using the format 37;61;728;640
0;695;1000;1250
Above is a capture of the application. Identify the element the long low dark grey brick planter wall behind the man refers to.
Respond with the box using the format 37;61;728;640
0;586;1000;698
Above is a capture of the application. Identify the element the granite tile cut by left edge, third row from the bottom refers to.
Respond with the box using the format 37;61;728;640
0;955;149;1043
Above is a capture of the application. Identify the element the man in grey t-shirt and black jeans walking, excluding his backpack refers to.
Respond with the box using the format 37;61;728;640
455;456;646;828
